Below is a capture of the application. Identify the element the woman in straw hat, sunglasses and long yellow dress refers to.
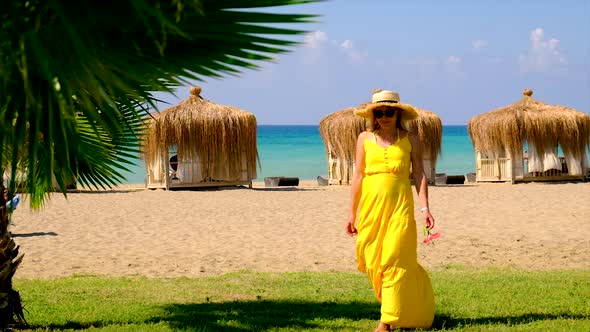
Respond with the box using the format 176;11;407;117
346;90;434;331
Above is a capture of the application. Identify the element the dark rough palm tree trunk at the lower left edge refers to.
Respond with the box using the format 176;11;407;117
0;186;26;330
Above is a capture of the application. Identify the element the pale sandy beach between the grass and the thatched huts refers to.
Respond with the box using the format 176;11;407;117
10;181;590;278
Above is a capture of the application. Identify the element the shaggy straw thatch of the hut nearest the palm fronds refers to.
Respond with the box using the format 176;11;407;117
142;87;258;181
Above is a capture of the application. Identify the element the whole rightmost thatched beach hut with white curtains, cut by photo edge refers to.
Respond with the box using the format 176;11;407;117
468;89;590;183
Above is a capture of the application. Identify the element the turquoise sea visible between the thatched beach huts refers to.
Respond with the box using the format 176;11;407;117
124;125;475;184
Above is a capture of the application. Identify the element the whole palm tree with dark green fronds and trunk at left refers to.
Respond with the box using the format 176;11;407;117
0;0;321;327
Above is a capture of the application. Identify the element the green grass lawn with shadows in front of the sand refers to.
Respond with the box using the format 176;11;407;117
14;267;590;332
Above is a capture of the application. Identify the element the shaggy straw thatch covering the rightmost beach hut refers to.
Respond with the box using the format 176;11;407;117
468;89;590;174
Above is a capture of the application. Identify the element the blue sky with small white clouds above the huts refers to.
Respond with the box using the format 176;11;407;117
156;0;590;125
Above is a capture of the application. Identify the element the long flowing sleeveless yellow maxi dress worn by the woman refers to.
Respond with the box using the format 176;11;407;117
356;134;434;328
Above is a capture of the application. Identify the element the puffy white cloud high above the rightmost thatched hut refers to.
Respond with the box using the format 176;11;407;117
519;28;567;72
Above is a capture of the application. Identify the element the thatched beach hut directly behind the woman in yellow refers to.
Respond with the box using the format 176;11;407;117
320;103;442;185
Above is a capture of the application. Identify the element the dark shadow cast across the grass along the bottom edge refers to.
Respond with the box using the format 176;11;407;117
28;301;588;332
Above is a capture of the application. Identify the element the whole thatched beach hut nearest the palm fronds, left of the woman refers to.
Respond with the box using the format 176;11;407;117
142;87;258;189
